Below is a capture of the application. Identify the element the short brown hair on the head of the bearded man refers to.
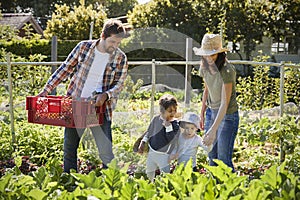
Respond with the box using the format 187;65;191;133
102;19;126;39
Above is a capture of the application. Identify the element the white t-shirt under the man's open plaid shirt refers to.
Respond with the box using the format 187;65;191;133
81;48;109;98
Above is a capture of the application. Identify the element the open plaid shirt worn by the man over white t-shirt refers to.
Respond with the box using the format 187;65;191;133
44;40;128;120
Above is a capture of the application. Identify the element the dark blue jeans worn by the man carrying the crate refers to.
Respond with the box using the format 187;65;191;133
64;117;114;173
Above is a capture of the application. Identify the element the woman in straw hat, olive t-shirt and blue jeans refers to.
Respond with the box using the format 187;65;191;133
193;34;239;171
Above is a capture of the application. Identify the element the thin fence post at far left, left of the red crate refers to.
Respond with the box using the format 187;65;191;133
6;53;16;145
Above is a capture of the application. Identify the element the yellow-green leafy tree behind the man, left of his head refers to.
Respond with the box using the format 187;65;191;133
44;2;106;40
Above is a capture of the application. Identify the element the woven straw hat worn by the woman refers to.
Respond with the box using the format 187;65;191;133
193;33;229;56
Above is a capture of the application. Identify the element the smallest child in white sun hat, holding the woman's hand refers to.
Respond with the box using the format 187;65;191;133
177;112;212;171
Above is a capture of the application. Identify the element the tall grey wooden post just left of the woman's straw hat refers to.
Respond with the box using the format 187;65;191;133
184;38;193;108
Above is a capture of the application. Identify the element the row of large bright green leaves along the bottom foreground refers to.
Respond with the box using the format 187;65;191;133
0;160;300;200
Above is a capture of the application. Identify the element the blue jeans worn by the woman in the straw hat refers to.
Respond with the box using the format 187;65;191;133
204;108;239;171
